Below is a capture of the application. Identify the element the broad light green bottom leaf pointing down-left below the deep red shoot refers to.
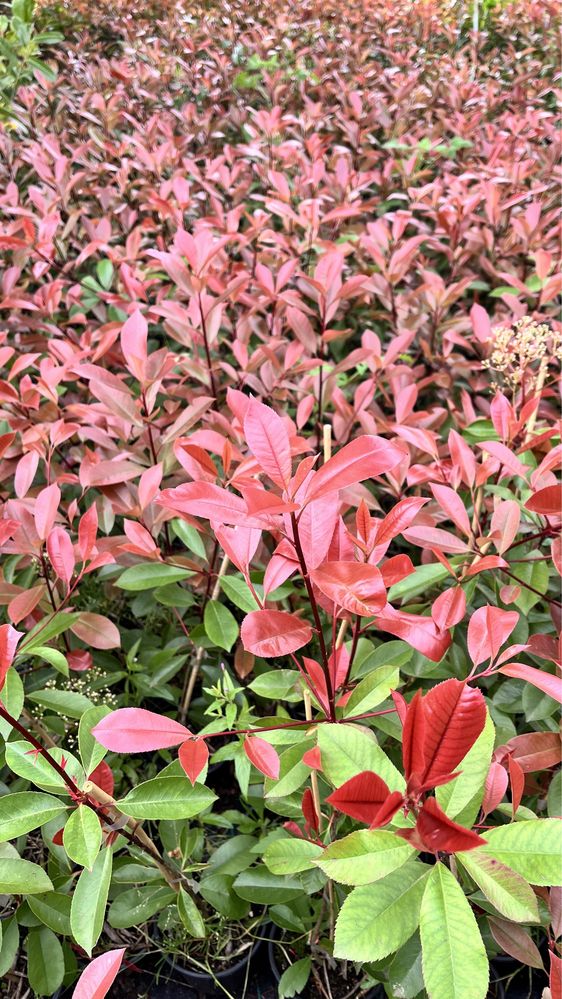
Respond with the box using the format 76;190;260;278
334;862;426;964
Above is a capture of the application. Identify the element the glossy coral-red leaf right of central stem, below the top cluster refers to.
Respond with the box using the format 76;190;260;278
310;562;386;617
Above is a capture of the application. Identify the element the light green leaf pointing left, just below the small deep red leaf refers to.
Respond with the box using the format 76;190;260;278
316;829;415;885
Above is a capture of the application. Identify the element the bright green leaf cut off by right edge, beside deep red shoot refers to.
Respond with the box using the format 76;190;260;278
481;819;562;885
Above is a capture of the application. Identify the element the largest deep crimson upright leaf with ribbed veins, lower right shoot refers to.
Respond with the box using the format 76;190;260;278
421;679;486;784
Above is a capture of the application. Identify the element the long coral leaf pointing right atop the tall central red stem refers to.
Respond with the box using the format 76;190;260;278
306;435;404;502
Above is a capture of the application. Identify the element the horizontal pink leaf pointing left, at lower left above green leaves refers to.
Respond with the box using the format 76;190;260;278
92;708;191;753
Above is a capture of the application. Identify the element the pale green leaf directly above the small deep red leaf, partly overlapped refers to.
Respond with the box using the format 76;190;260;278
318;724;405;791
